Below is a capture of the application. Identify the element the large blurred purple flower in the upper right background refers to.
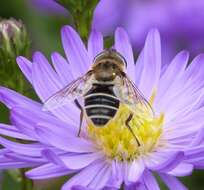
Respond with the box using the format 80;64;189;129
93;0;204;61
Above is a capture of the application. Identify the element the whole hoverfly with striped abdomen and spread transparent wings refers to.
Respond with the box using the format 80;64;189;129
44;49;152;144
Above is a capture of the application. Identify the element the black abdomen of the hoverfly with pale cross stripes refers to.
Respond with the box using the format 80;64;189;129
84;84;120;126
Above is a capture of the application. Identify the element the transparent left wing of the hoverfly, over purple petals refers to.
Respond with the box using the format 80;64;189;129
43;71;92;110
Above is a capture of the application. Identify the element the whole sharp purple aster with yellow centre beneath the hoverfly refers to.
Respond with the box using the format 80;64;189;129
0;26;204;190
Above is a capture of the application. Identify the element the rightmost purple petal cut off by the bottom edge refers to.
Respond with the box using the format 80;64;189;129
159;174;187;190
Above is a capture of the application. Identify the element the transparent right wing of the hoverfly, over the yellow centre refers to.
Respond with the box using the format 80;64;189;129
115;75;154;117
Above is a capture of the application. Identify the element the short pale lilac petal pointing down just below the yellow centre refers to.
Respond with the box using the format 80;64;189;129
128;159;145;182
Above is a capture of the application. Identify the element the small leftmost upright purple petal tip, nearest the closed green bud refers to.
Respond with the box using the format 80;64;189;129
16;56;32;84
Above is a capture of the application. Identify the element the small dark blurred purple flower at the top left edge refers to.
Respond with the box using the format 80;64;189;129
28;0;67;15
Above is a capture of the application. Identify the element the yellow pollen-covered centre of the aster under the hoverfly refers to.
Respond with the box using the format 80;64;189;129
87;101;164;161
